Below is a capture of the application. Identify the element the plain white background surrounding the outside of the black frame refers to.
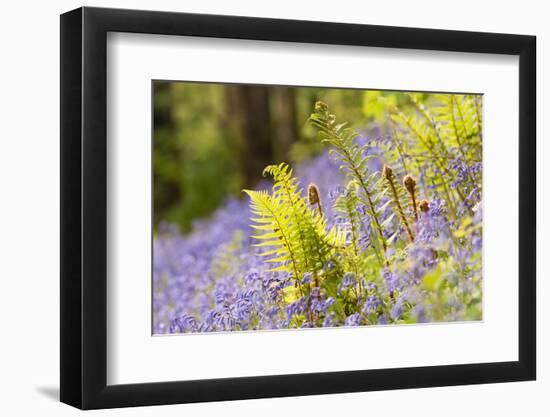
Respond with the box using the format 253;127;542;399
0;0;550;417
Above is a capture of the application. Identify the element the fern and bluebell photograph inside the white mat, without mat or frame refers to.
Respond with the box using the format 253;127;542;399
153;80;483;335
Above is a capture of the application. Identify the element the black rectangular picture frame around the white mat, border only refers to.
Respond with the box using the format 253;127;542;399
60;7;536;409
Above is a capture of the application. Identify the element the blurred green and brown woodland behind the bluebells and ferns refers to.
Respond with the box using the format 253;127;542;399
153;81;410;232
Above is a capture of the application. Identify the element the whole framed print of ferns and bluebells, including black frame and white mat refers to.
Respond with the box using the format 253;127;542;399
61;7;536;409
